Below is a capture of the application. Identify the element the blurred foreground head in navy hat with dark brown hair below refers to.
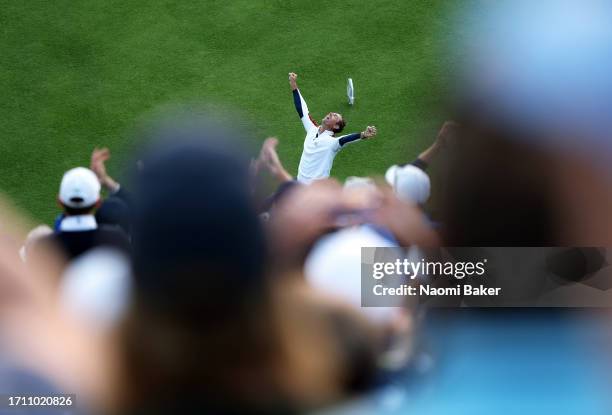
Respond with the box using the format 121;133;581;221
124;115;276;407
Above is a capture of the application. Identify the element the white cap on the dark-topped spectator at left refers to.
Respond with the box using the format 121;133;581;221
59;167;101;208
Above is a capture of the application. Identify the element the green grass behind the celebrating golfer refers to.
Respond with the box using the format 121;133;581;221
0;0;449;223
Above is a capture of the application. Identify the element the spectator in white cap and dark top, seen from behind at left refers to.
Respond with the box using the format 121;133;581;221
31;167;129;260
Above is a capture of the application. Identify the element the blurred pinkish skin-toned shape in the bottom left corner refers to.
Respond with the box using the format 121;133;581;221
0;203;117;414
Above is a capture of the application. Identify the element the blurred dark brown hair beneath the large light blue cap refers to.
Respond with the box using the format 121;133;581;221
441;117;558;246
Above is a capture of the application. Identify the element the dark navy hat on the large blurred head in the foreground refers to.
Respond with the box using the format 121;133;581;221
132;119;264;312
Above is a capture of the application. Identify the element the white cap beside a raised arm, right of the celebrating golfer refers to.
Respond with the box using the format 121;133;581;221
385;164;431;205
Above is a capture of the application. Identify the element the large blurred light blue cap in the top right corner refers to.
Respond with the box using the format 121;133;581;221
462;0;612;155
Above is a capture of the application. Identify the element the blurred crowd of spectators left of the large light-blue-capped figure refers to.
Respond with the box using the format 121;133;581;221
1;113;456;413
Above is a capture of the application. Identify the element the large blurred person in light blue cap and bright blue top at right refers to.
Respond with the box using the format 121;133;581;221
412;0;612;414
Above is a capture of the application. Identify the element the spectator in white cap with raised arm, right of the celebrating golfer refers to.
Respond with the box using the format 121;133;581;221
385;121;456;205
